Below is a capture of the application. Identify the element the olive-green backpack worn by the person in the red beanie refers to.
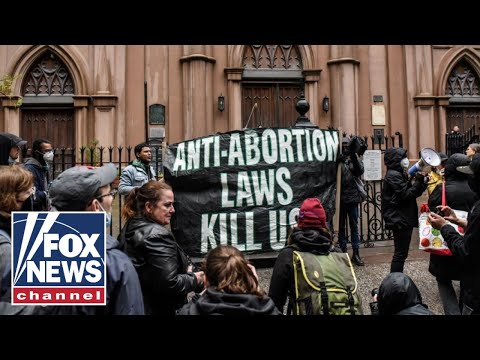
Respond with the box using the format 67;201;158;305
293;251;363;315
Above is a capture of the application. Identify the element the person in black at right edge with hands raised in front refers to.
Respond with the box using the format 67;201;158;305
428;154;480;315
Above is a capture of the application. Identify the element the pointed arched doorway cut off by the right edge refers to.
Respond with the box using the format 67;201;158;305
445;59;480;135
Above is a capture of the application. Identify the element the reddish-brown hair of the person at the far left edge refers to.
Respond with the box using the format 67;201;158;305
0;165;33;218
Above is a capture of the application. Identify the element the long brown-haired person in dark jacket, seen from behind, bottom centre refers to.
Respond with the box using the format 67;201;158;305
178;245;282;316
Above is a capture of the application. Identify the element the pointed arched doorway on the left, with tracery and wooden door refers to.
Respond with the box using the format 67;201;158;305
20;50;75;162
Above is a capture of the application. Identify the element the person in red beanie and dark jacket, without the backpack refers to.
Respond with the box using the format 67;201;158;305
268;198;362;314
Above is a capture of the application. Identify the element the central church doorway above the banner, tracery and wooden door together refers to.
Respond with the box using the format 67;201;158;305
242;45;303;128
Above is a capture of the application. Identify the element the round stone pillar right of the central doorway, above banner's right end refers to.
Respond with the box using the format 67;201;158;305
327;45;360;134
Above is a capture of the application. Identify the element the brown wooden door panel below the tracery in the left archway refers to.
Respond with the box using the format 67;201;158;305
20;109;75;175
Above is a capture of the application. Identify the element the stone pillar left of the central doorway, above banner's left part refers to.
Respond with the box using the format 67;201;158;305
180;45;216;139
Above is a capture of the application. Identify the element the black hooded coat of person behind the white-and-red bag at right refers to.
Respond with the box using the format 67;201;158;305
428;154;478;280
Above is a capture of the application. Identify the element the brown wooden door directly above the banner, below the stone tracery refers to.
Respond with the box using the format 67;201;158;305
242;83;300;128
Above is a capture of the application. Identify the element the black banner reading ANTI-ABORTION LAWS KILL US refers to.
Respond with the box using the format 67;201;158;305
164;128;338;256
